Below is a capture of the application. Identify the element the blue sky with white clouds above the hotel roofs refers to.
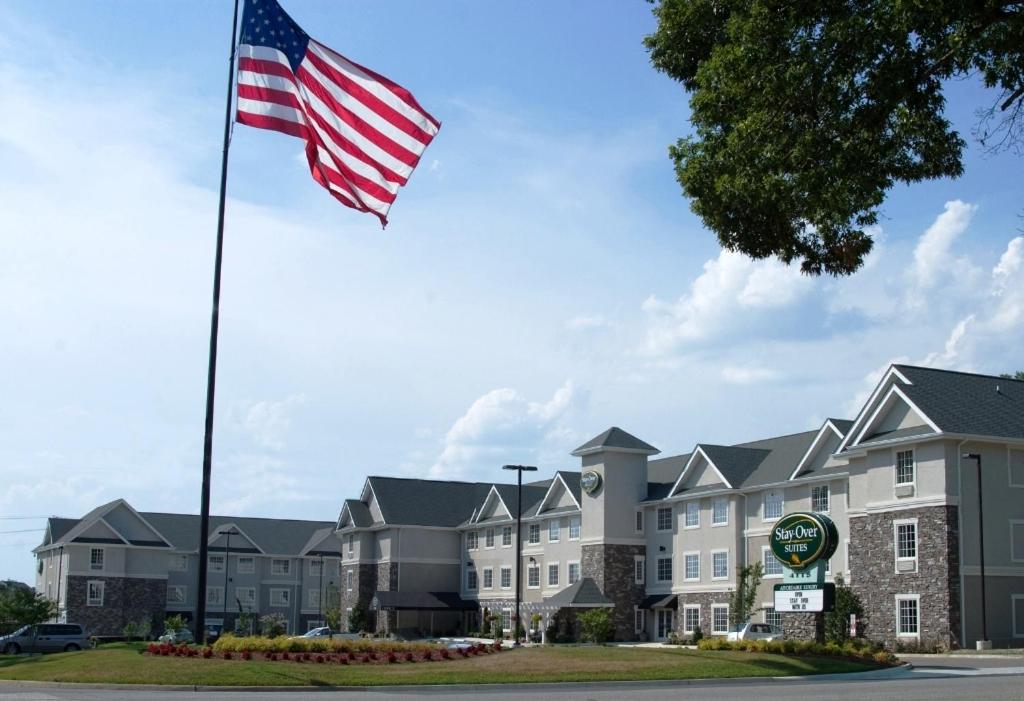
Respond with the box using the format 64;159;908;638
0;0;1024;581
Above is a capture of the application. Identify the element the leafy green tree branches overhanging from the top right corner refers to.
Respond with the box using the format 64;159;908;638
644;0;1024;275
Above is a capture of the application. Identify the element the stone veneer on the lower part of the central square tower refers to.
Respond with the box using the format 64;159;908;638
580;543;647;641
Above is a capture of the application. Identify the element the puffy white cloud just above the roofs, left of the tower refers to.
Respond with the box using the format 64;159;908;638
430;381;577;479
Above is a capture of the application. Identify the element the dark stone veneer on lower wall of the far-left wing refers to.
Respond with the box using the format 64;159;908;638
67;575;167;636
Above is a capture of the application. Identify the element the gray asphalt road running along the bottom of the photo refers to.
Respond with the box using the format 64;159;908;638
0;657;1024;701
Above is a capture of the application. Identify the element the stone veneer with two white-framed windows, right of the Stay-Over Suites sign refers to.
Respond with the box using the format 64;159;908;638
850;506;961;648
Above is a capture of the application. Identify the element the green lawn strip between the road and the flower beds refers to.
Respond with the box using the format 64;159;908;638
0;644;871;686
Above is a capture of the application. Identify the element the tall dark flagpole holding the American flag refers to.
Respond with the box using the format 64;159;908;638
195;0;239;643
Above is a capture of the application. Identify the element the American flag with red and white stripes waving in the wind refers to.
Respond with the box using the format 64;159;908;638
238;0;440;224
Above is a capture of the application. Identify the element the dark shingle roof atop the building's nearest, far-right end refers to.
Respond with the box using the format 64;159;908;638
895;365;1024;438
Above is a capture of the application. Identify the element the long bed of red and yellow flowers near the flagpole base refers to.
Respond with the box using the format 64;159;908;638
145;636;502;664
